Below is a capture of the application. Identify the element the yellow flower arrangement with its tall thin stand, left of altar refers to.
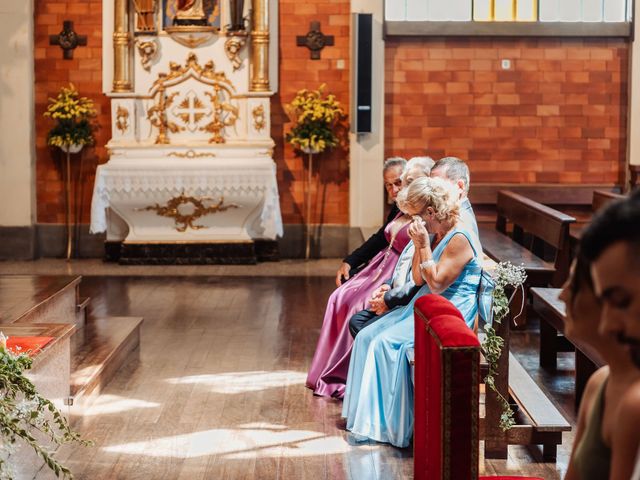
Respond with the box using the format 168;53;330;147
44;84;96;260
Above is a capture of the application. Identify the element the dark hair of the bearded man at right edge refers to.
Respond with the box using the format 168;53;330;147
580;189;640;263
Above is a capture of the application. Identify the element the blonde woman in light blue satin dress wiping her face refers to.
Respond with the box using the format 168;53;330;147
342;177;481;447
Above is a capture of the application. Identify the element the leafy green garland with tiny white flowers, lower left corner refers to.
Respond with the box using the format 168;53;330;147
0;333;93;479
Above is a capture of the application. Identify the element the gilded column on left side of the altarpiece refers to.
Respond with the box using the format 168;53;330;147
113;0;133;93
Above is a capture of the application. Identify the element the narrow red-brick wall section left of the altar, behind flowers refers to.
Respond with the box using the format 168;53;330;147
34;0;111;223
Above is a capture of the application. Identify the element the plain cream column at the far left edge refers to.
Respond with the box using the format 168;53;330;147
0;0;35;227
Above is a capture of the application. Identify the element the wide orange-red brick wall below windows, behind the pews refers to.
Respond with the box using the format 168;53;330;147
385;38;629;184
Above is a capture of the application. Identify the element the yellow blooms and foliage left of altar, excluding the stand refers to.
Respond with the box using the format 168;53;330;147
44;84;96;148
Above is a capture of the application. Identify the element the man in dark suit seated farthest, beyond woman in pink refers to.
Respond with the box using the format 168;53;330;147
336;157;407;287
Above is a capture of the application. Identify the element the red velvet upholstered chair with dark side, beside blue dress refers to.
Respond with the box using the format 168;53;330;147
413;294;542;480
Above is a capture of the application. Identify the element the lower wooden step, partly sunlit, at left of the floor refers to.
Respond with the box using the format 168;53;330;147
71;317;143;410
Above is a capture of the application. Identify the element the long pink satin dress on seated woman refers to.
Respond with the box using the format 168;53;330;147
307;214;410;398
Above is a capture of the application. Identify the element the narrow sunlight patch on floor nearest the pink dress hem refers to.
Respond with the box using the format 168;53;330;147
167;370;307;394
